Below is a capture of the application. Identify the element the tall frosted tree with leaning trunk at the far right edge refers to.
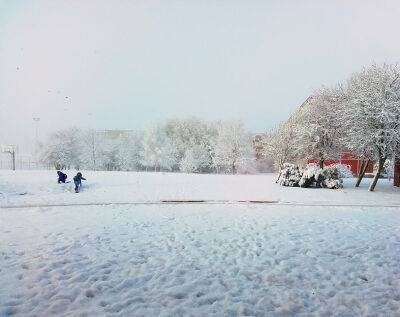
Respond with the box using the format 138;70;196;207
342;64;400;191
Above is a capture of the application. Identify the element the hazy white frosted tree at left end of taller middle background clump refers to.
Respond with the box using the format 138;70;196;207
142;125;178;171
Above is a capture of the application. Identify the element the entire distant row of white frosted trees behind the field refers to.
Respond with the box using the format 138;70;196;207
39;118;255;173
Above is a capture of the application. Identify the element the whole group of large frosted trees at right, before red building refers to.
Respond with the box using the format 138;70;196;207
262;64;400;191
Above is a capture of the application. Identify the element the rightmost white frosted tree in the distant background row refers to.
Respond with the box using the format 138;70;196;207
213;121;255;174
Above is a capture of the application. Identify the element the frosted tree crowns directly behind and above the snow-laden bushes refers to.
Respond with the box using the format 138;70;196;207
264;87;344;170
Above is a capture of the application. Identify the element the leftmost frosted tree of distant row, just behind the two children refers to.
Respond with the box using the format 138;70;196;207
41;128;82;169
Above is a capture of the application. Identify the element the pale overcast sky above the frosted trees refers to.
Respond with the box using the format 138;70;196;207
0;0;400;153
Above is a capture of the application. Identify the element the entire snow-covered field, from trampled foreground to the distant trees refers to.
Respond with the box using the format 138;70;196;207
0;171;400;316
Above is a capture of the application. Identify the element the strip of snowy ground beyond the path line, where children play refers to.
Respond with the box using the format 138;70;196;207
0;171;400;207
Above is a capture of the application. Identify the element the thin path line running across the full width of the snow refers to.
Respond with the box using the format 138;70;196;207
0;200;400;209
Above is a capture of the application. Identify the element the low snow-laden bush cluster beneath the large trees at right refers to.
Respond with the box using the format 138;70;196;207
277;163;343;189
